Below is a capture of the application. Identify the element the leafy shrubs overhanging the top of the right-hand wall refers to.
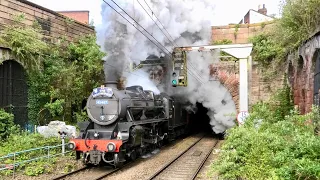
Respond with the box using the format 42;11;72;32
251;0;320;68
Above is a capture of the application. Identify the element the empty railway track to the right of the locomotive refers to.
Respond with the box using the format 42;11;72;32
149;136;219;180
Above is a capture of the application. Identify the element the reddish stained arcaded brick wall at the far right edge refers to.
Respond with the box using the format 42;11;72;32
288;32;320;114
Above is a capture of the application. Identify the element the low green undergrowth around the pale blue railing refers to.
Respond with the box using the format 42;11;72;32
0;131;74;176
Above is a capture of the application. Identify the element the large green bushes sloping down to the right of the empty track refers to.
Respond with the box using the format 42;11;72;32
208;85;320;179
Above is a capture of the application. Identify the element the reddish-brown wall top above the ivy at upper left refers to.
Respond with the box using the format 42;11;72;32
0;0;95;40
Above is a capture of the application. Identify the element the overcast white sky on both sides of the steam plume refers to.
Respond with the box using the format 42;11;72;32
29;0;280;25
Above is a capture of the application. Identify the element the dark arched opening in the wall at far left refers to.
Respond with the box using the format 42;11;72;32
0;60;28;128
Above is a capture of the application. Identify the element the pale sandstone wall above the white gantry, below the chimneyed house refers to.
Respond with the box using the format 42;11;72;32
211;22;273;44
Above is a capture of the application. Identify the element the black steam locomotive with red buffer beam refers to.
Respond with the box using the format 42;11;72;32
69;83;188;167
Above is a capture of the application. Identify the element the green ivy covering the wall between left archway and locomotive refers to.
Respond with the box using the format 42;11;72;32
0;16;106;125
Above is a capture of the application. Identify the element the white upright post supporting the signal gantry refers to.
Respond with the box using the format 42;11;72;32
239;59;249;112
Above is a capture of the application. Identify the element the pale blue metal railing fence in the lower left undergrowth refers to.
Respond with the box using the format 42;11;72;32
0;140;71;175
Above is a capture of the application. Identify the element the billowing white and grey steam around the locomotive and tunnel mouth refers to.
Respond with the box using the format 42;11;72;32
97;0;236;133
